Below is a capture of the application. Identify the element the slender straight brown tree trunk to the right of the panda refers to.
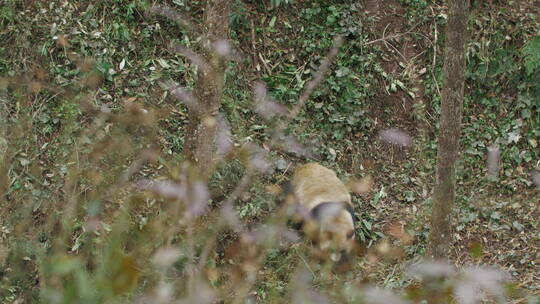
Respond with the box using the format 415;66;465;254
428;0;469;259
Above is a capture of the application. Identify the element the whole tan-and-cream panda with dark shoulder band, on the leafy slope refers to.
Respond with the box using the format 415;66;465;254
290;163;355;261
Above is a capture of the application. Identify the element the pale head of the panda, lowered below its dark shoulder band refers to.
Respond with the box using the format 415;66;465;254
304;202;355;260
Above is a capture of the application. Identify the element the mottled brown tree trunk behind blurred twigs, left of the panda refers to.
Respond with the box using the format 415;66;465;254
184;0;230;178
